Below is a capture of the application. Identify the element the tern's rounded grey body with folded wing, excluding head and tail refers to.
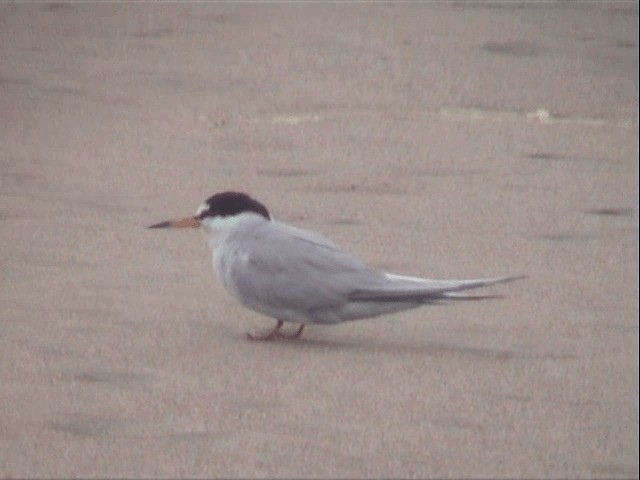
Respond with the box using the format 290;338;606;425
222;222;386;320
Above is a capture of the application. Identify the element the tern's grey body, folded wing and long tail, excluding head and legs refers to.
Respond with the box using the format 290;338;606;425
220;222;522;322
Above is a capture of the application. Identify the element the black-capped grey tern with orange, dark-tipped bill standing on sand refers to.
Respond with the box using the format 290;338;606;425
148;191;524;340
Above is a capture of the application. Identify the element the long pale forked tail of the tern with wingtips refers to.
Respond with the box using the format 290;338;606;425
349;273;526;303
